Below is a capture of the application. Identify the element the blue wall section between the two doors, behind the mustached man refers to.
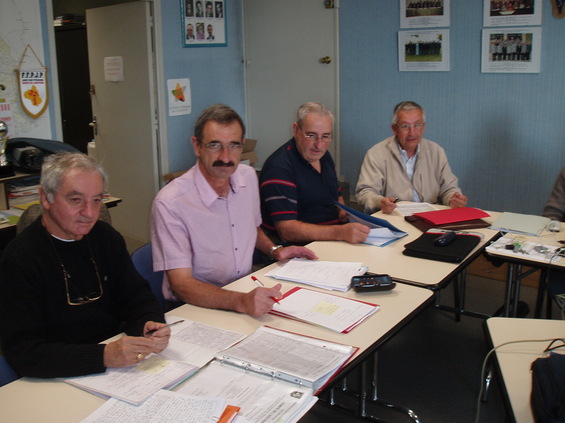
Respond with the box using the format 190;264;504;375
161;0;245;172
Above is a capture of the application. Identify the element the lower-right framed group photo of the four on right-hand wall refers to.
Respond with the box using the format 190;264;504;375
481;28;541;73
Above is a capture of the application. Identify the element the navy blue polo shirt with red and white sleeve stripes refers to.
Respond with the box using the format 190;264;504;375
259;138;340;232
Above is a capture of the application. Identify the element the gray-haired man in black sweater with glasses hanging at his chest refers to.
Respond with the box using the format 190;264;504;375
0;153;170;377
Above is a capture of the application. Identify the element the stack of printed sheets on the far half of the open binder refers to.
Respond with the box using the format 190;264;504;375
216;326;356;387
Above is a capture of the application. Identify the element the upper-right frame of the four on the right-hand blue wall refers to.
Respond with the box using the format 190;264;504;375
483;0;543;26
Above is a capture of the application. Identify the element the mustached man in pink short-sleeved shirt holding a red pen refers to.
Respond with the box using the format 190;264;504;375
151;104;317;316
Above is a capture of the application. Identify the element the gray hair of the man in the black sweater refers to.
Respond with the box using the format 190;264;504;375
40;152;108;203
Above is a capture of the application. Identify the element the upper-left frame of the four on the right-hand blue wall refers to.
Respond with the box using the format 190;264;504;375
399;0;451;28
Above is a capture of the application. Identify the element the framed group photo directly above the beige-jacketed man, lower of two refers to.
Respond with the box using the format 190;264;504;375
398;29;449;72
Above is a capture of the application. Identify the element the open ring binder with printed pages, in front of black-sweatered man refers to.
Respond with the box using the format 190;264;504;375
178;326;358;423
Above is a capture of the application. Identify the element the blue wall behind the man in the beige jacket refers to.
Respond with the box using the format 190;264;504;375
340;0;565;214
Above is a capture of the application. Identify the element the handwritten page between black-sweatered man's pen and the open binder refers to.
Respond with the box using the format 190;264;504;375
159;316;245;367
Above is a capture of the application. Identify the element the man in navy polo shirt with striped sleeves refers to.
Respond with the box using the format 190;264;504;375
259;102;369;243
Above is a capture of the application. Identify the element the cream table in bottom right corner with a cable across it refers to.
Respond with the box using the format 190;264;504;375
486;317;565;423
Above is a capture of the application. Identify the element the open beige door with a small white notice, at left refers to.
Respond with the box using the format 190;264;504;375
86;2;161;242
